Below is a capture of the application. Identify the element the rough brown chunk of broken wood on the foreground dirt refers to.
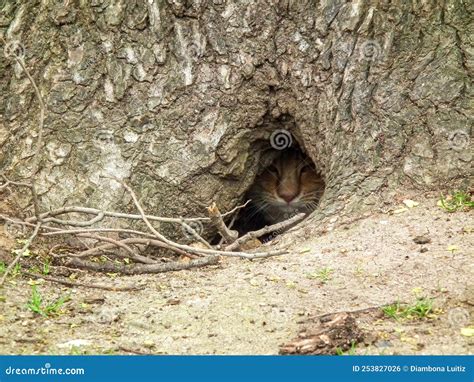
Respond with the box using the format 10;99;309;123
279;313;363;355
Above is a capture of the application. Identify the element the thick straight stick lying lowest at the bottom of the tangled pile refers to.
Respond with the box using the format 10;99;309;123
65;256;219;275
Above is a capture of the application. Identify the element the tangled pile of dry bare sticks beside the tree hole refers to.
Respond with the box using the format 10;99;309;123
0;176;305;284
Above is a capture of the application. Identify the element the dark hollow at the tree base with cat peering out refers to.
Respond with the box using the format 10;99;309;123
233;140;325;242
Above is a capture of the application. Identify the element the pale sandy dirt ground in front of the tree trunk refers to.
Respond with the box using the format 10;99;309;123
0;199;474;354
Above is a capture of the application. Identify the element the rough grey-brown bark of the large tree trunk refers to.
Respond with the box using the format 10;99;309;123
0;0;474;233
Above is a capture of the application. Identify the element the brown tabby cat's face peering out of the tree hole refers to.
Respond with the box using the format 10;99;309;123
249;150;324;224
